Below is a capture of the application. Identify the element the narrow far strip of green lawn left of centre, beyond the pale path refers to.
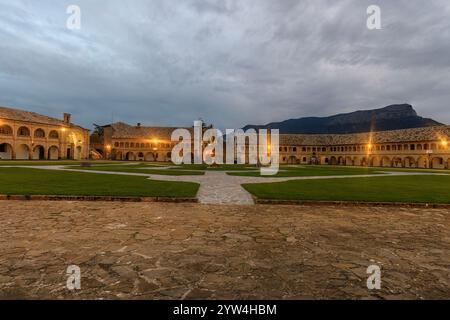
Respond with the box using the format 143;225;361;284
66;164;205;176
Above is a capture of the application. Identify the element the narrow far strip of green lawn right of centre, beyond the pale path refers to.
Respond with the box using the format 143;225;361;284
228;166;381;178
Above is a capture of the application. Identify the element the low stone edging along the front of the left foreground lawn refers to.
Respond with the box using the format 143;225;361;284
0;194;198;203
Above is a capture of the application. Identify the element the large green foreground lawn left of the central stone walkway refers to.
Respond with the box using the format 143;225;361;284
0;167;199;197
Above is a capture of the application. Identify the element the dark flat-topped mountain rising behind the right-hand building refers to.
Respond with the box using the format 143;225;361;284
243;104;442;134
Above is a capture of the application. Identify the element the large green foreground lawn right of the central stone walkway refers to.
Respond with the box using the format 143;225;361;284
243;175;450;203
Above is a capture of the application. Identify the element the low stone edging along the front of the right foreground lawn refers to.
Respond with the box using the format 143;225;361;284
253;197;450;209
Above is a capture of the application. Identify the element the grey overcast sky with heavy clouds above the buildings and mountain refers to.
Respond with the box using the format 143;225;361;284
0;0;450;128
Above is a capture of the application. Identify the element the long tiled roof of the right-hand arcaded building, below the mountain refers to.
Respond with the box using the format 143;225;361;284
280;126;450;146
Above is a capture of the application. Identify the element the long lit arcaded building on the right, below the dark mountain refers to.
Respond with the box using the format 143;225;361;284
280;126;450;169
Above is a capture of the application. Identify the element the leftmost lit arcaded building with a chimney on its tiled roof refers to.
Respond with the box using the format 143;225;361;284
0;107;89;160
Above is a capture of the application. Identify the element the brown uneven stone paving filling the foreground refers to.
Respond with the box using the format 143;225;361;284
0;201;450;299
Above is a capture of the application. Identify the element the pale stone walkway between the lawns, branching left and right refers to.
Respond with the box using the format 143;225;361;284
8;166;447;205
